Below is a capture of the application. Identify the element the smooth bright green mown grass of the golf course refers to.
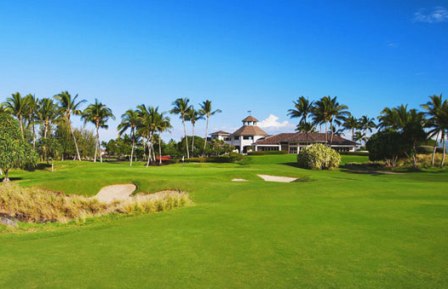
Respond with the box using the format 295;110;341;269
0;155;448;289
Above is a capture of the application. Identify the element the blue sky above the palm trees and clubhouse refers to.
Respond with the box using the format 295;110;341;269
0;0;448;138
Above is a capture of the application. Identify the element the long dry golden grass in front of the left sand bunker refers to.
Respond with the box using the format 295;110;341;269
0;184;190;223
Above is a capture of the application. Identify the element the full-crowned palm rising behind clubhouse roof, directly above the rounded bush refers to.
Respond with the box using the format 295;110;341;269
313;96;350;143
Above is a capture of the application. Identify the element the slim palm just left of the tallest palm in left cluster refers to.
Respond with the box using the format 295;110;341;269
36;98;59;161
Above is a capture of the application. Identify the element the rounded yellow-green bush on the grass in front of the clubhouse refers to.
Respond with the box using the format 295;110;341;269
297;144;341;170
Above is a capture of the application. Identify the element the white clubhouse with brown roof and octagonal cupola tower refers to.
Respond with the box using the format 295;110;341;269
210;116;356;154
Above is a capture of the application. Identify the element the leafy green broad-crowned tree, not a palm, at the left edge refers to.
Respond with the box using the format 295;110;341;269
0;113;36;182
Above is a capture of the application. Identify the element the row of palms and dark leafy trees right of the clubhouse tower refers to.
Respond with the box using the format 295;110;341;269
288;94;448;167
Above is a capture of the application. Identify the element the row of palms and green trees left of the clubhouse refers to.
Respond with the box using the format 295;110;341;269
0;91;222;166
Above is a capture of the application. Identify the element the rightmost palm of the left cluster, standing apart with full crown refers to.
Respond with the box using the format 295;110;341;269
81;99;115;162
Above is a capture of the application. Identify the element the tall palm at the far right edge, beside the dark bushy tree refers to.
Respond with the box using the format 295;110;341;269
421;94;448;167
